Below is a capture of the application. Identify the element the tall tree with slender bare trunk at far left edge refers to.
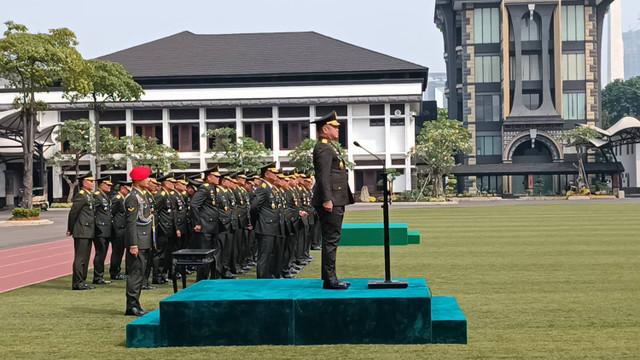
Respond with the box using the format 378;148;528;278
0;21;82;208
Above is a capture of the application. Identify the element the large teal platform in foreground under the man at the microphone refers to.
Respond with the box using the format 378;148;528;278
127;279;467;347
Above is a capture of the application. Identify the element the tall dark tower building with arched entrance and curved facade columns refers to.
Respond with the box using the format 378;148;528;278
435;0;619;195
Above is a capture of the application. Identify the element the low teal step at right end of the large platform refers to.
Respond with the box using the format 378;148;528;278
431;296;467;344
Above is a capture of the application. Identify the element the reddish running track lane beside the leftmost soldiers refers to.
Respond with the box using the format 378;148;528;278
0;238;111;293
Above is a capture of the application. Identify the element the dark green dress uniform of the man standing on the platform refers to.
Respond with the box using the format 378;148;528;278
313;139;354;285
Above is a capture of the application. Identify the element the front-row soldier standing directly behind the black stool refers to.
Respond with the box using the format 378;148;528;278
191;166;222;280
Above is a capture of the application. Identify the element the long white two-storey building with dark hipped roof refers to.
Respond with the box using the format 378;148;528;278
0;31;428;199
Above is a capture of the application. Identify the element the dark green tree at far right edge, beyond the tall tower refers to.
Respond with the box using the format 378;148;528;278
601;77;640;128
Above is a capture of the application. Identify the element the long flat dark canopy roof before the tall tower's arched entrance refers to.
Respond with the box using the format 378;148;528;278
450;162;624;176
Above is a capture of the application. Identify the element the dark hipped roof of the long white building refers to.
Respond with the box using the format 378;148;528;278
100;31;427;78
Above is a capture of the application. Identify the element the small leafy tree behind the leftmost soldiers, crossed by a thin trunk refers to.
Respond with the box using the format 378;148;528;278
47;119;124;202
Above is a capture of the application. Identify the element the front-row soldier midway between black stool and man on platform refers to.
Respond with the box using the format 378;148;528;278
251;163;285;279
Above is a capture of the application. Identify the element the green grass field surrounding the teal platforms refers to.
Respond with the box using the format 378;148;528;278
0;203;640;359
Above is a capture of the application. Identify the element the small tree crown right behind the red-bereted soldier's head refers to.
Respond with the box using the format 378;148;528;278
122;134;189;173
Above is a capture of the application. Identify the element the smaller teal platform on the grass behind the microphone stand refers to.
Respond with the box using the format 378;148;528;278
340;223;420;246
